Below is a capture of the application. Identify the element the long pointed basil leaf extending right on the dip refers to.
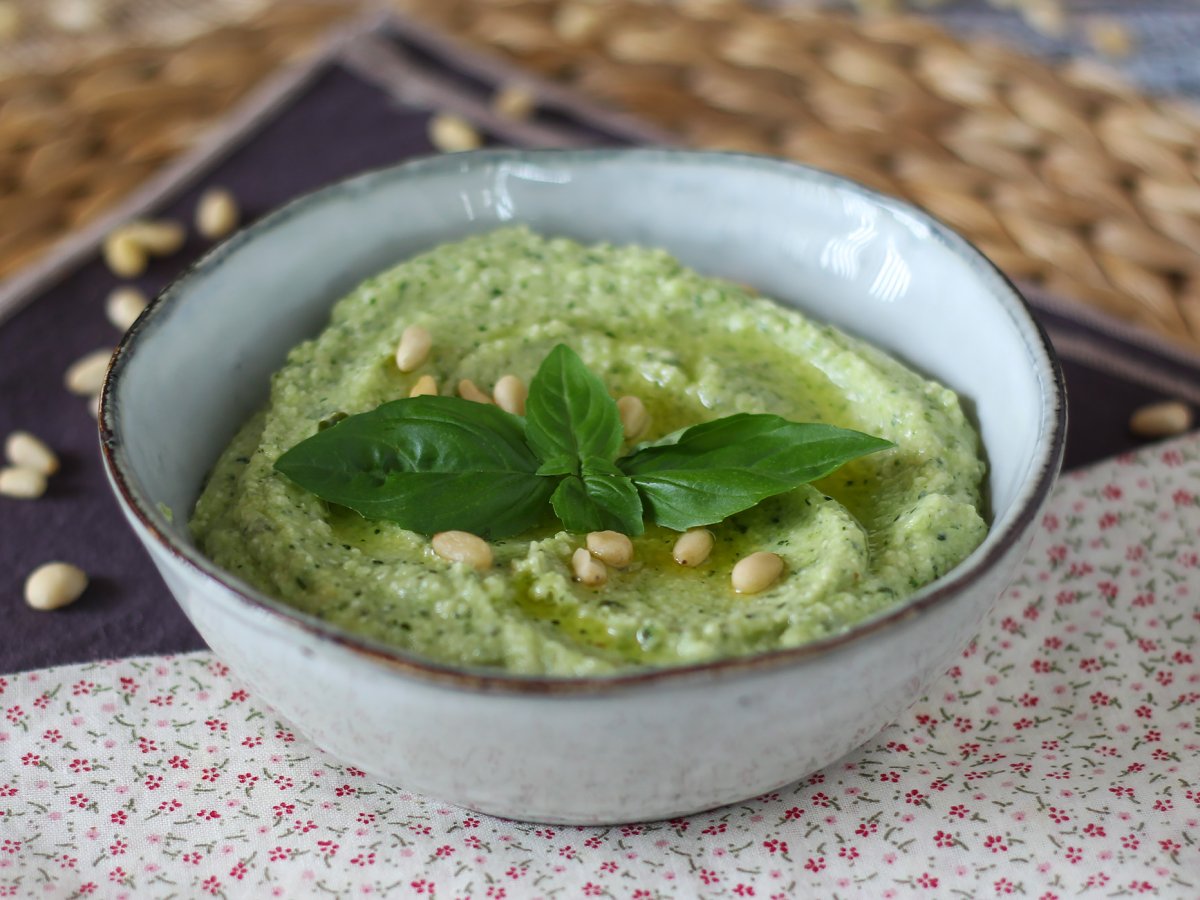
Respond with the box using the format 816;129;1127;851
618;413;894;532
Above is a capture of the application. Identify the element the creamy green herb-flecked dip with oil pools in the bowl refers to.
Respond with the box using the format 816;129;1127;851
191;229;986;676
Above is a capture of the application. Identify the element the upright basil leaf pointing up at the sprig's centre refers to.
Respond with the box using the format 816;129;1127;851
526;343;622;474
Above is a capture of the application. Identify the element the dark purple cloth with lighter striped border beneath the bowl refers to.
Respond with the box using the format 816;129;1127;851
0;15;1200;672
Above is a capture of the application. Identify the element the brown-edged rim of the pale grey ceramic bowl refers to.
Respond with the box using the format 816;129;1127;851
97;148;1067;697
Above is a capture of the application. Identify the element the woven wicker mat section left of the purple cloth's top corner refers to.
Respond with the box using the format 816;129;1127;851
0;1;349;278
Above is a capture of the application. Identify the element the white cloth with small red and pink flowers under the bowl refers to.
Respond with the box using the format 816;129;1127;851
0;436;1200;900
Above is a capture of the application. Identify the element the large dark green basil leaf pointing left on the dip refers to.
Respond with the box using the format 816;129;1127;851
275;396;554;539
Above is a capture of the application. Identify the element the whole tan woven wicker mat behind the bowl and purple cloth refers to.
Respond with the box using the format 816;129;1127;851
0;0;1200;347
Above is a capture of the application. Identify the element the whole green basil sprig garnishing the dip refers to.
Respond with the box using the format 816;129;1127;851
275;344;894;540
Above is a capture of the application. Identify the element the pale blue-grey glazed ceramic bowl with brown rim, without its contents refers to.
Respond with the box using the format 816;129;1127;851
101;150;1064;823
